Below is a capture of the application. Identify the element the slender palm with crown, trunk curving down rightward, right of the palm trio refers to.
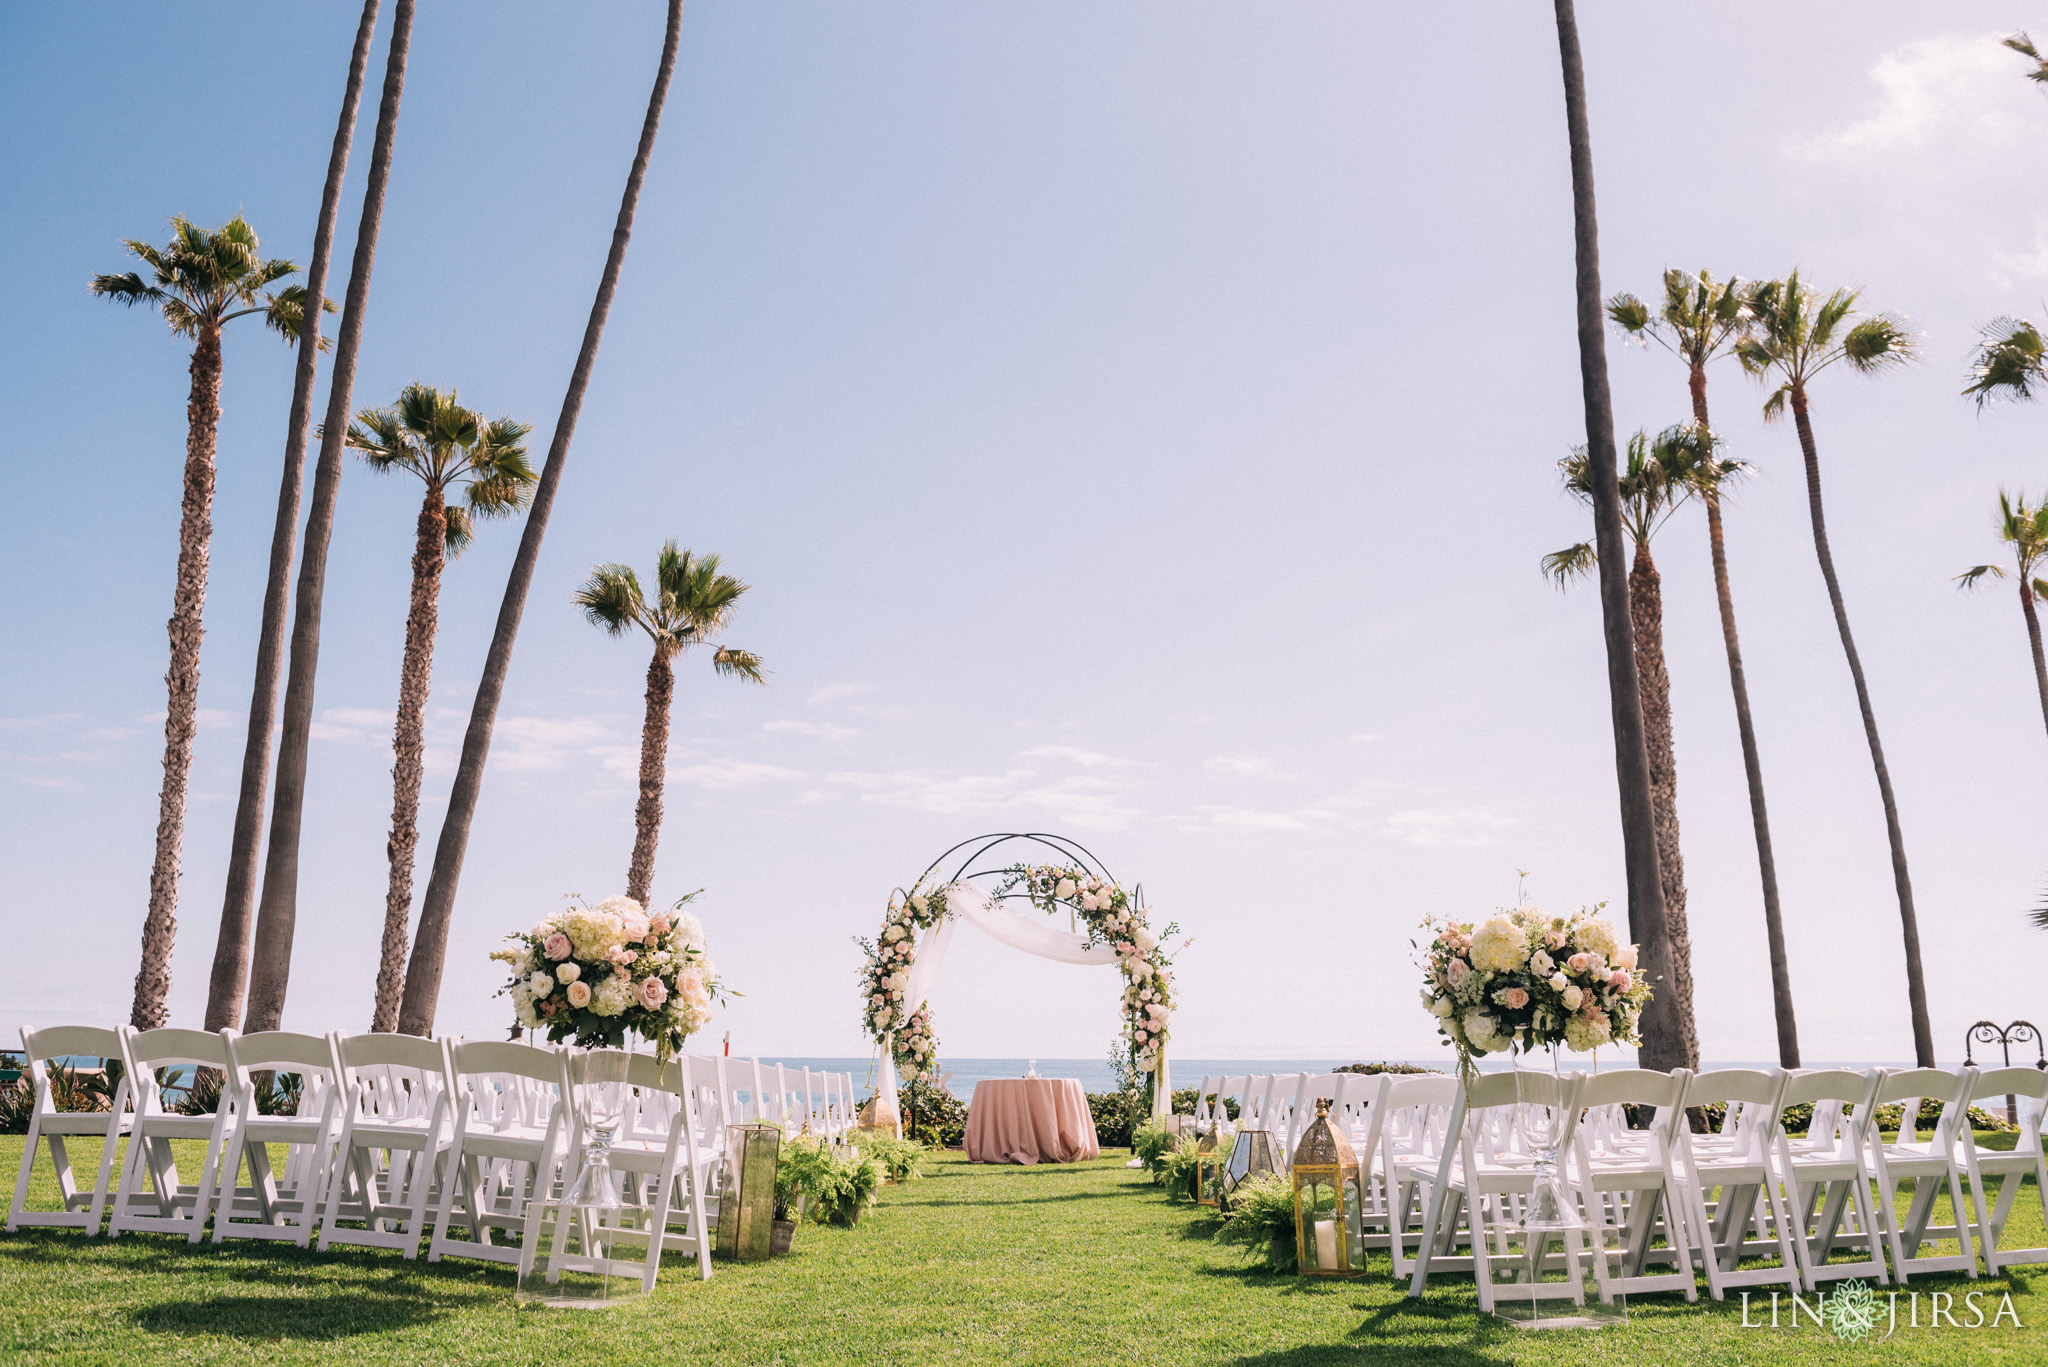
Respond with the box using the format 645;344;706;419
1735;271;1933;1068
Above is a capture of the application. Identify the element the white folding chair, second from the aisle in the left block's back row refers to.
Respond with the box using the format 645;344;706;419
426;1039;565;1265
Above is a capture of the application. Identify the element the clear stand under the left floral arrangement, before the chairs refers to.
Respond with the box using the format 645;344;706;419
512;1049;647;1310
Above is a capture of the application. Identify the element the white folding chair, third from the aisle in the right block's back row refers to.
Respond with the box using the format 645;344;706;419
1677;1068;1800;1301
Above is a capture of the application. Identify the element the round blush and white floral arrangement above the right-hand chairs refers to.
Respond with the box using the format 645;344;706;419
1421;902;1651;1078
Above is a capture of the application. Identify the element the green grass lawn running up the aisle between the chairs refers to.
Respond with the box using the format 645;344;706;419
0;1137;2048;1367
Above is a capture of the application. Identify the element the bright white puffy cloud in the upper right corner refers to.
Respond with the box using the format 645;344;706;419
1786;33;2048;162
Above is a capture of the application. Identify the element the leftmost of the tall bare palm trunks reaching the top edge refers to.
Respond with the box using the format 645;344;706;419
207;0;379;1031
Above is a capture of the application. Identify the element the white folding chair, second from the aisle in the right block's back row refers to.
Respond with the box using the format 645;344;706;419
1573;1068;1700;1301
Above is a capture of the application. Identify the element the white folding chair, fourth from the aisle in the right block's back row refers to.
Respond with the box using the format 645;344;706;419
1774;1068;1890;1291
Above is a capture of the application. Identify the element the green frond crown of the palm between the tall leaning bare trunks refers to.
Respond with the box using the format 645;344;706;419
348;385;535;555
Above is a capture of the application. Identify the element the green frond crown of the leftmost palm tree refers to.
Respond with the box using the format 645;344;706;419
90;213;334;348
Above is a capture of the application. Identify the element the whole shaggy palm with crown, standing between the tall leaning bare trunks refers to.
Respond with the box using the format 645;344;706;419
348;385;532;1033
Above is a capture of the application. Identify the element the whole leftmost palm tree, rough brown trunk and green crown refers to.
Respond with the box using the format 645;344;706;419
92;213;305;1029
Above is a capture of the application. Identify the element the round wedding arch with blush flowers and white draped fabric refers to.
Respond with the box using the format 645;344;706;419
860;830;1178;1115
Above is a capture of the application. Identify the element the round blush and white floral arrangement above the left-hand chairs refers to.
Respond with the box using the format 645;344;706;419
492;894;725;1062
